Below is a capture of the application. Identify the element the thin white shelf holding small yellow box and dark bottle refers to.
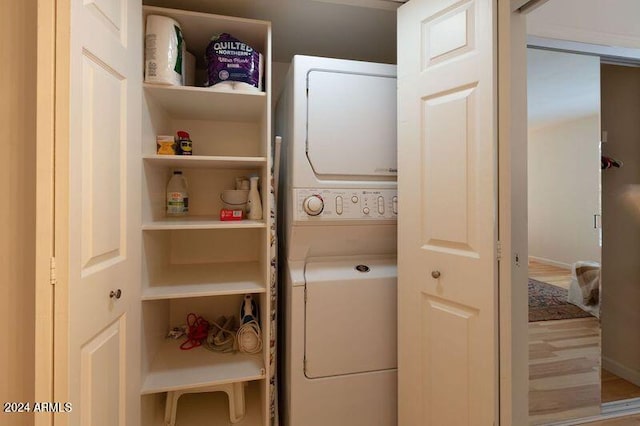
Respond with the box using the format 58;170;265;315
142;155;267;169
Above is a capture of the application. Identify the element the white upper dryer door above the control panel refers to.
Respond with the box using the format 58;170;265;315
307;70;397;179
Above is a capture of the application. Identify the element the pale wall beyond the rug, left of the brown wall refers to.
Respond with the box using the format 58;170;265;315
528;115;600;265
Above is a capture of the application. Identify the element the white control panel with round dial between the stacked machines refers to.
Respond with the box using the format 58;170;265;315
293;189;398;222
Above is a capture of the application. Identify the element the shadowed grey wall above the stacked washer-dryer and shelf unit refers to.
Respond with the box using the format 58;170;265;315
143;0;400;64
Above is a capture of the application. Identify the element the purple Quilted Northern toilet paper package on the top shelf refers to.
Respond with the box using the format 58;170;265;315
205;33;264;91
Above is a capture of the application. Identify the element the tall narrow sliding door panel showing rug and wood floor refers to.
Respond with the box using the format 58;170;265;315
527;48;601;425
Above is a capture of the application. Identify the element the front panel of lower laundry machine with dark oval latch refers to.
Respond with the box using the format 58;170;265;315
305;259;397;378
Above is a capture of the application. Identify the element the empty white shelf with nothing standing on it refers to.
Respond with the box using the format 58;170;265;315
142;262;267;300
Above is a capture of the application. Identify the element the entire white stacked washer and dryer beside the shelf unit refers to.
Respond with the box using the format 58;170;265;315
276;56;398;426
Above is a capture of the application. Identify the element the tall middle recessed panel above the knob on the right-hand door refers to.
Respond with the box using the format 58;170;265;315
421;86;477;256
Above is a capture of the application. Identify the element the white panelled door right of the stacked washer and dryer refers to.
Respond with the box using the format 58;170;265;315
398;0;498;426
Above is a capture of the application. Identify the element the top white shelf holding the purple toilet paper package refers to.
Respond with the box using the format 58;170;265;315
143;83;267;122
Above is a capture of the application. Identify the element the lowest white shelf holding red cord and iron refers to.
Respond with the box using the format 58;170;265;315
141;339;265;395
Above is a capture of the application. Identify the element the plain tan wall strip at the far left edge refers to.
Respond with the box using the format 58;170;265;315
0;0;37;426
